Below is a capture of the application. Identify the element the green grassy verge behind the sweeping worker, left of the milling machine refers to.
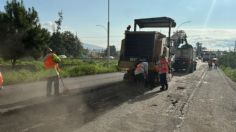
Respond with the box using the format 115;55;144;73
0;59;118;85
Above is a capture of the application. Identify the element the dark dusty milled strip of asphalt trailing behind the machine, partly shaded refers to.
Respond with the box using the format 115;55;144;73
0;82;158;131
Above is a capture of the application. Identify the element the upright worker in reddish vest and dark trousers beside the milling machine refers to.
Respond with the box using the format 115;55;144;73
158;56;169;90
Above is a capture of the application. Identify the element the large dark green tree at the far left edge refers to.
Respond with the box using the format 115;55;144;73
0;0;49;67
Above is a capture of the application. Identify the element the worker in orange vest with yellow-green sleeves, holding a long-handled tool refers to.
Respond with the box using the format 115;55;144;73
44;48;61;96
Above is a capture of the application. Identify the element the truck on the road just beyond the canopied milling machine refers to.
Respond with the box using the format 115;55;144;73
173;44;197;73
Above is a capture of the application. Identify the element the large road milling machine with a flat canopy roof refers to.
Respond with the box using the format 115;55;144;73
118;17;176;83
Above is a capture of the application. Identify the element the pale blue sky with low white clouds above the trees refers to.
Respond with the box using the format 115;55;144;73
0;0;236;50
